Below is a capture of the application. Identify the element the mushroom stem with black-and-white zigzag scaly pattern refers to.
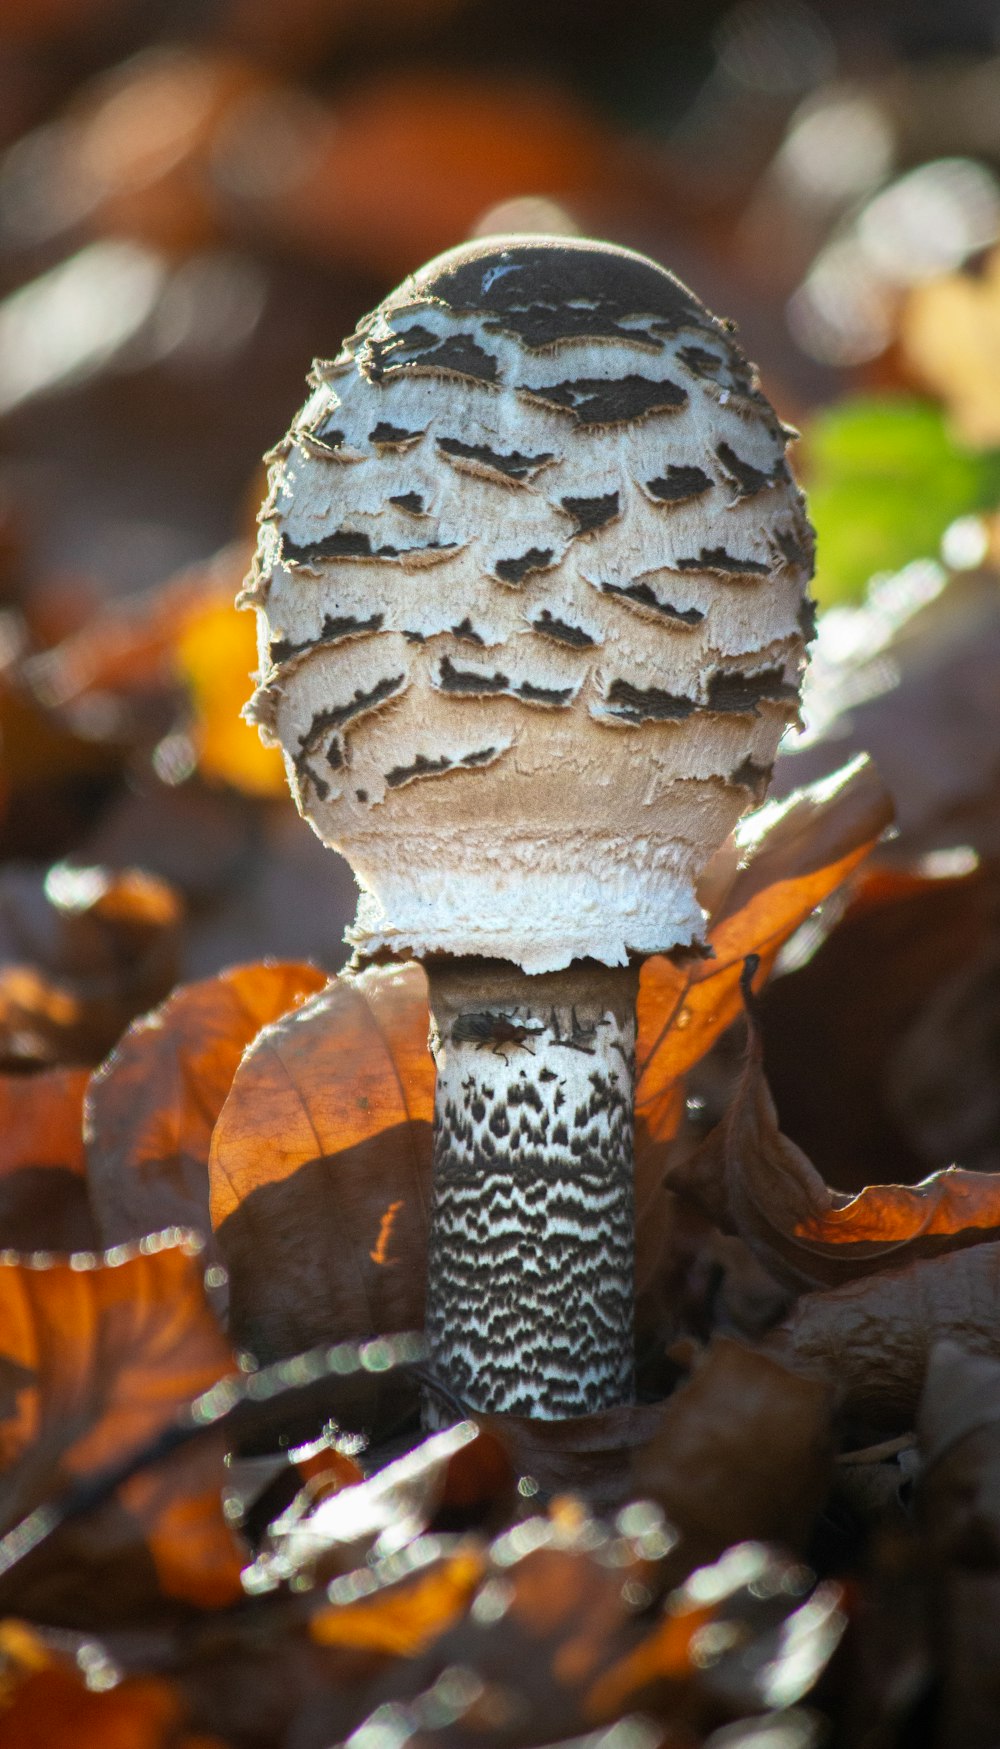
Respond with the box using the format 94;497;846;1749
427;958;638;1420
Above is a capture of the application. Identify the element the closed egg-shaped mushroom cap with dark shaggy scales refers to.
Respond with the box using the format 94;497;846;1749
241;236;813;972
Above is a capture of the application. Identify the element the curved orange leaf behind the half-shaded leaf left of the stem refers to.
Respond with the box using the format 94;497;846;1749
86;962;327;1245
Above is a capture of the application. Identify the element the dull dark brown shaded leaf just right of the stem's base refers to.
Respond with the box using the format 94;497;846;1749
629;1336;832;1572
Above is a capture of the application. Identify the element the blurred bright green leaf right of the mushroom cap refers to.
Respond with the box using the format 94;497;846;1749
804;395;1000;607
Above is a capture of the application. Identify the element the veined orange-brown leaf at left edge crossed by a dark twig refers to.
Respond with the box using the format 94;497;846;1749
0;1233;240;1627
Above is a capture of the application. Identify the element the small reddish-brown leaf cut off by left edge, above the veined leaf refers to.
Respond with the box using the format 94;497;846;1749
0;1069;98;1251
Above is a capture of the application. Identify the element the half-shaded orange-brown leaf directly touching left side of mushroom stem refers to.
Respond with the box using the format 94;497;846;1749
210;965;434;1361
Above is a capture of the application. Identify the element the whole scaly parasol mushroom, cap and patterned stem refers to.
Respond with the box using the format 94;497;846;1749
241;236;813;1418
